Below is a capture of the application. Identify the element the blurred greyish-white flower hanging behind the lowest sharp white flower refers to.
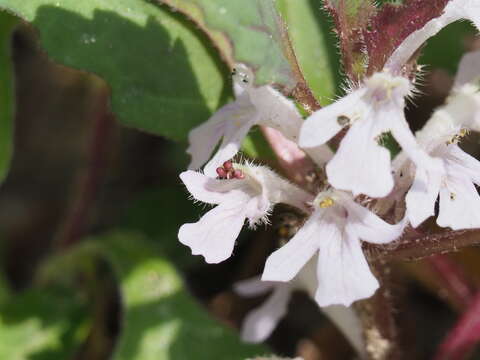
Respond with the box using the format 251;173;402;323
234;259;366;358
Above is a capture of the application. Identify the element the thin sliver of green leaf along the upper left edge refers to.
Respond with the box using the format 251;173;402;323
0;13;18;182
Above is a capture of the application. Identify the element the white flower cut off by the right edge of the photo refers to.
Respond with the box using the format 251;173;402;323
403;52;480;230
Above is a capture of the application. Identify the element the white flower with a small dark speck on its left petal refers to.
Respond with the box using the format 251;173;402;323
300;72;431;197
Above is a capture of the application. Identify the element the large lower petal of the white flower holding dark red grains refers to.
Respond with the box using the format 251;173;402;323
178;199;248;264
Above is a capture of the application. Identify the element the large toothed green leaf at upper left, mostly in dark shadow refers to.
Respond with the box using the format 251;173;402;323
0;0;230;140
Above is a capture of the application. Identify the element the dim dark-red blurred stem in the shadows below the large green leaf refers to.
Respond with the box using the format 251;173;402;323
57;85;114;248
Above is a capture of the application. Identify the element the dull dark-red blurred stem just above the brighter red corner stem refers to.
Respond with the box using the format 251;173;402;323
426;255;475;308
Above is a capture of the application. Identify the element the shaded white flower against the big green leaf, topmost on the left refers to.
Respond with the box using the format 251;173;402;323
187;65;303;176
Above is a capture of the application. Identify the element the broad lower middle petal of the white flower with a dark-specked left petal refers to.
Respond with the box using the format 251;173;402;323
327;118;393;197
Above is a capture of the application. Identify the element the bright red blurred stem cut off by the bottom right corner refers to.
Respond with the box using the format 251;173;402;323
434;292;480;360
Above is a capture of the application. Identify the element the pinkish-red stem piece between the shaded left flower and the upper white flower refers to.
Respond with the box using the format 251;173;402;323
261;126;315;188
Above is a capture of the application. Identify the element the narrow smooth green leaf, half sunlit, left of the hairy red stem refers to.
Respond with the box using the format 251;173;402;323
277;0;341;105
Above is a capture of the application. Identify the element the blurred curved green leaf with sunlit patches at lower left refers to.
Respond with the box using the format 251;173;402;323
61;232;265;360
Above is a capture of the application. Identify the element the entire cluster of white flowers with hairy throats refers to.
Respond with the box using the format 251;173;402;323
178;0;480;348
